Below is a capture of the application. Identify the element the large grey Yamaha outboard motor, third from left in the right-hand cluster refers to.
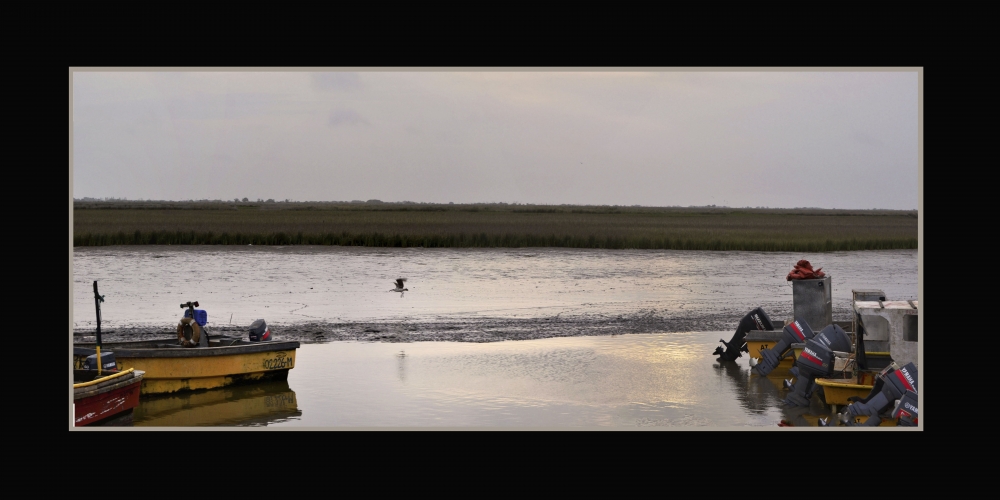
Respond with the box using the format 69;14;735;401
785;325;851;406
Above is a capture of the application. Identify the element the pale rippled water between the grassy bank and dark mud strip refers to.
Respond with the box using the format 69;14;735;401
73;246;918;331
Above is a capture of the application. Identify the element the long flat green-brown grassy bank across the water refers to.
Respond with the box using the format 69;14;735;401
73;201;917;251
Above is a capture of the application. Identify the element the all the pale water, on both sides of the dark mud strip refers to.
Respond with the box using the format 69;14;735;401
73;247;918;428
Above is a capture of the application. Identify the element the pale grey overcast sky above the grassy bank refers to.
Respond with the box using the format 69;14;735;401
72;70;919;209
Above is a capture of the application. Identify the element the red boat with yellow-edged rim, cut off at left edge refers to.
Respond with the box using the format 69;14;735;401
73;368;145;427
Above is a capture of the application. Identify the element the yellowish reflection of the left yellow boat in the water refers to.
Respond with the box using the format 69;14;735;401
134;380;302;427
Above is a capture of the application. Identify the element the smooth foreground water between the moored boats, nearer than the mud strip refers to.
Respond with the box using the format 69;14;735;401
134;332;829;428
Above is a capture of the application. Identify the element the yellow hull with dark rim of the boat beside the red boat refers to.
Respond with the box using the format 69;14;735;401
73;340;299;394
